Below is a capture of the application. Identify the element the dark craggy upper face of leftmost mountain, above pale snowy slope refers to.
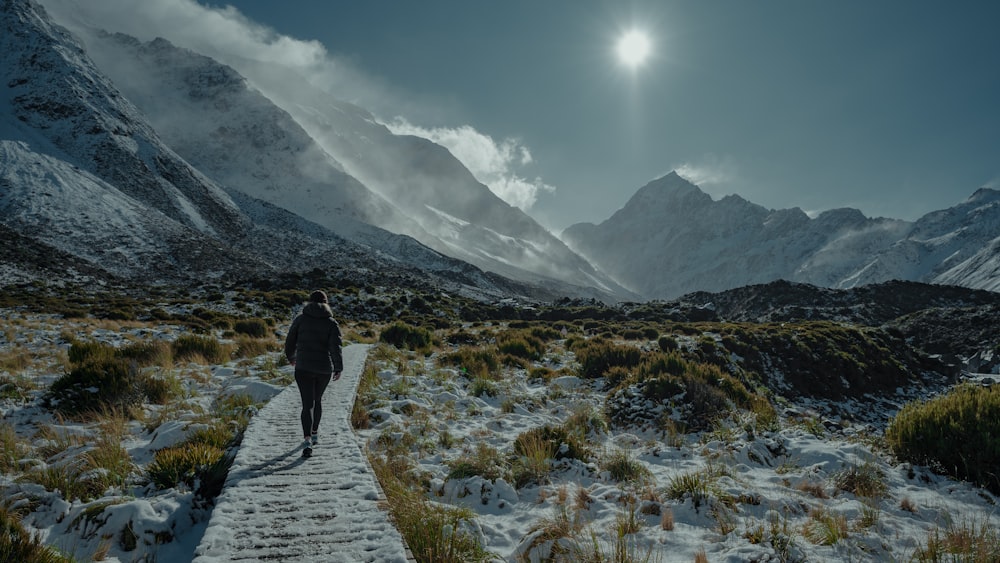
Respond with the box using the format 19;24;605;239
0;1;246;241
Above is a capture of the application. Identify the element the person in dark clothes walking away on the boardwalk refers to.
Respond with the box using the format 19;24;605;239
285;290;344;457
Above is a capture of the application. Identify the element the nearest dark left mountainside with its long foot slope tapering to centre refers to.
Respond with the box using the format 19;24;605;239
0;0;548;297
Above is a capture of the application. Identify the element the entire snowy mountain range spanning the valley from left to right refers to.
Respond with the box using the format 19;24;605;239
0;0;1000;301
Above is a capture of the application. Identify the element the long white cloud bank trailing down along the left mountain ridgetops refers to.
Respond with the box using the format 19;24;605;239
41;0;555;210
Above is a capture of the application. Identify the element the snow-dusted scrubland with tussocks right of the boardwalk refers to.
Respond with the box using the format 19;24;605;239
354;321;1000;561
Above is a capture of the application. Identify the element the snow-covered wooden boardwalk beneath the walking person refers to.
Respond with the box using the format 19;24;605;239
194;345;407;563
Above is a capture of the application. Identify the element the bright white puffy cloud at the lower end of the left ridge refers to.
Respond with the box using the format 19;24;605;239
386;117;555;210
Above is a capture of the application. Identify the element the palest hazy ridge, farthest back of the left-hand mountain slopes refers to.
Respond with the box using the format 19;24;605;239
204;58;635;298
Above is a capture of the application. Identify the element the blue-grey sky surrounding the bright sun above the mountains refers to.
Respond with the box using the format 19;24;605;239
43;0;1000;230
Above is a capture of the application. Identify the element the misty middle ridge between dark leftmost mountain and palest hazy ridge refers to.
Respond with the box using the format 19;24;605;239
77;32;417;242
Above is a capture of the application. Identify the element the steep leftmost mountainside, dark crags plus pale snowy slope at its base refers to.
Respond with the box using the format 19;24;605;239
0;1;258;275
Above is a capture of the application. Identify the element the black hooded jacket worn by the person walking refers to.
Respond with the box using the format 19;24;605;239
285;301;344;374
